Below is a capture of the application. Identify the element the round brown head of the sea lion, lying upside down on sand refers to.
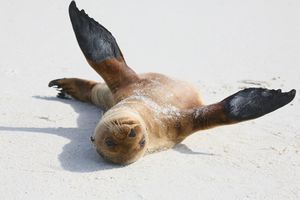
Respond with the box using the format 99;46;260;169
91;108;148;164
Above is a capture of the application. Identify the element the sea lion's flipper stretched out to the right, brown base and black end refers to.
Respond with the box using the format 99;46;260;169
191;88;296;132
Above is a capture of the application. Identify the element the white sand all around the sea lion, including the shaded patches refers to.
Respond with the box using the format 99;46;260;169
0;0;300;200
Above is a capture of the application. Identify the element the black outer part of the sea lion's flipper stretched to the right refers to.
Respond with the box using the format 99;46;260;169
222;88;296;121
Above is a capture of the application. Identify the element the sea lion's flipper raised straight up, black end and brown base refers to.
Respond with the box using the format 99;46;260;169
69;1;139;93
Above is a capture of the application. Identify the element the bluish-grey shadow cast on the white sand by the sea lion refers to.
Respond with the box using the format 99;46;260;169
0;96;213;172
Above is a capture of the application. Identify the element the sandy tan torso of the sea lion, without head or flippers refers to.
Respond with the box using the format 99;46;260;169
92;73;203;152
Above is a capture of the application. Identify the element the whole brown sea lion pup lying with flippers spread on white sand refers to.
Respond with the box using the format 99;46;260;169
49;1;296;164
